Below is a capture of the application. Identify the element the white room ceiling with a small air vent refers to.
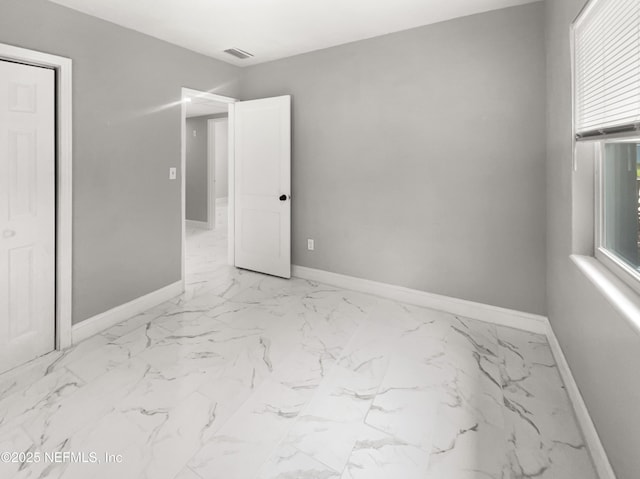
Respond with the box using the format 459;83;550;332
50;0;537;66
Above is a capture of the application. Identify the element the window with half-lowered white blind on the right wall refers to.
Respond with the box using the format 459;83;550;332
573;0;640;292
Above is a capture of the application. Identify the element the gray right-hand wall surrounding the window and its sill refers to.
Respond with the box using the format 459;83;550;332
545;0;640;479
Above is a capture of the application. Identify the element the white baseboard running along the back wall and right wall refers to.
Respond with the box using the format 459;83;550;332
292;265;615;479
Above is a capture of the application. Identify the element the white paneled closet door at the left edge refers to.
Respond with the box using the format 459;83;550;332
0;61;55;372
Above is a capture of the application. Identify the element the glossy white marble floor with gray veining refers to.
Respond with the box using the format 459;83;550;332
0;212;596;479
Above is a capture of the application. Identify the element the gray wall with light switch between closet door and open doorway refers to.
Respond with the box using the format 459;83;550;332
0;0;239;323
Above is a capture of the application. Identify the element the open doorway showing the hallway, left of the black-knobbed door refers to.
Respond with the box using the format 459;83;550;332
181;88;235;294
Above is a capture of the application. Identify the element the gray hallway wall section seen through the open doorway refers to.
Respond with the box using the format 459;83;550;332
185;117;209;221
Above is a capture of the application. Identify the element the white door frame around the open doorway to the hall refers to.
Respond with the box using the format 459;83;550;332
180;87;238;290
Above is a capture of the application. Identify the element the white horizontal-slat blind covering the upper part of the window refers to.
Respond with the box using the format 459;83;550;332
574;0;640;139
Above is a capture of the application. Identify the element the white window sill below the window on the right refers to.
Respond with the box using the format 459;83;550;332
571;254;640;334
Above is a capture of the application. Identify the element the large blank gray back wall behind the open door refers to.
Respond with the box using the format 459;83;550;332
241;3;545;313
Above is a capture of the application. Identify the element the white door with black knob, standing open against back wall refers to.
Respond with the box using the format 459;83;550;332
233;96;291;278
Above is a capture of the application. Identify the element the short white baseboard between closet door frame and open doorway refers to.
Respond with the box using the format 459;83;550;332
71;281;184;344
